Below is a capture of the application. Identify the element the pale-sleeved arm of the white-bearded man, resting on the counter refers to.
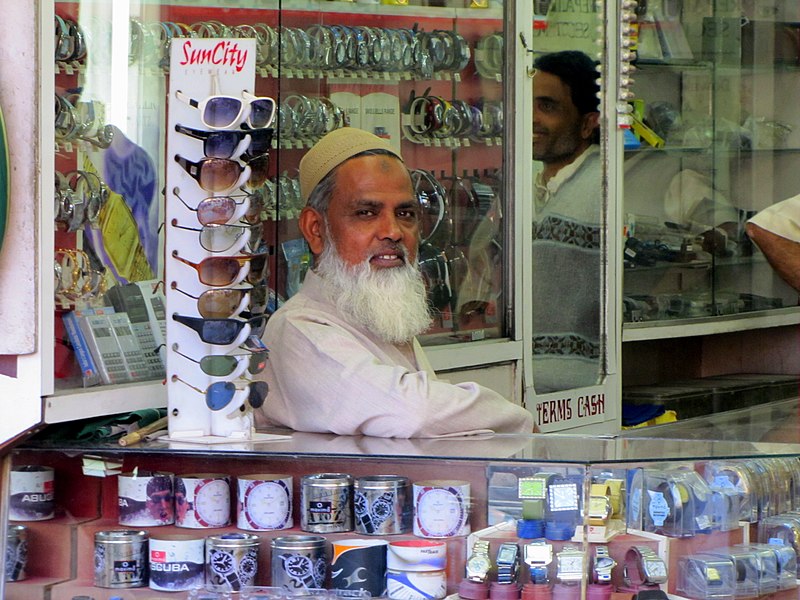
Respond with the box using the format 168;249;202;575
266;321;533;437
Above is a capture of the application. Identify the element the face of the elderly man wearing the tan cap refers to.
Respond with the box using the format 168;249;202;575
306;156;419;269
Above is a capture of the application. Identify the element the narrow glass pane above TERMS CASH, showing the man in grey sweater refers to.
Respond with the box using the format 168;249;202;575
527;3;605;394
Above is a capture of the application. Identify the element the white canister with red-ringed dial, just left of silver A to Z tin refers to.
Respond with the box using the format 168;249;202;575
236;474;294;531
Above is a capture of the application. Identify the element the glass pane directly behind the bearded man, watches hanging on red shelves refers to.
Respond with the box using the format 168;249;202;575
275;0;506;344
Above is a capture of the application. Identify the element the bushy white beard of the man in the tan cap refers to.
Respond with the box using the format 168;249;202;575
316;237;431;344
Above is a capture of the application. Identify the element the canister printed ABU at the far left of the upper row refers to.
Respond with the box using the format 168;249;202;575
8;465;55;521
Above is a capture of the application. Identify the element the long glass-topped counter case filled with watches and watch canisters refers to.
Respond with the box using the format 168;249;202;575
4;424;800;600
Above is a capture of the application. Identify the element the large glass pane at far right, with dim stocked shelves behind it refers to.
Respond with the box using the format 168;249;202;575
624;2;800;322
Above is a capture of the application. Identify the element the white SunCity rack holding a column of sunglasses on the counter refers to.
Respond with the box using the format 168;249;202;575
164;40;276;443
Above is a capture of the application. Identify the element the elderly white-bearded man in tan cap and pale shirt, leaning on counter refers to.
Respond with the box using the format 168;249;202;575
259;127;533;438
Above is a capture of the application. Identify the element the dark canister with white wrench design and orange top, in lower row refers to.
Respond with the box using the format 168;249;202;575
331;539;388;598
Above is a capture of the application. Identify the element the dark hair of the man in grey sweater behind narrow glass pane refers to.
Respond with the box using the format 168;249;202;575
533;50;600;115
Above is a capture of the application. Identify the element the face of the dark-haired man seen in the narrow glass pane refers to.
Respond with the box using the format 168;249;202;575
533;71;598;172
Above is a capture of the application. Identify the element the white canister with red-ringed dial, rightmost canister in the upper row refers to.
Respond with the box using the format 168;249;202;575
414;480;470;538
